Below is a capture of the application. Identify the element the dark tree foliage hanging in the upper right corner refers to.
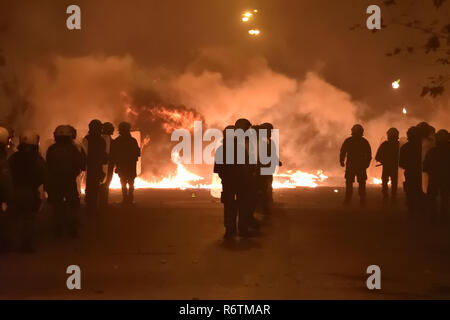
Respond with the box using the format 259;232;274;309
350;0;450;97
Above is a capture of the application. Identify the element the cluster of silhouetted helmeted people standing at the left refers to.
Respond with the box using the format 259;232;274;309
0;120;140;252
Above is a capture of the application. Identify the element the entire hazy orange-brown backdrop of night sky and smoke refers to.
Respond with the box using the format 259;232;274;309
0;0;450;177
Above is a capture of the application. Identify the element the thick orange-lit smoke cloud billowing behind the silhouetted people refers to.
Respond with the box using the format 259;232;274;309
1;54;449;179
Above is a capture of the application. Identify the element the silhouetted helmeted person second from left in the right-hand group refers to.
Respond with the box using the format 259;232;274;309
375;128;400;201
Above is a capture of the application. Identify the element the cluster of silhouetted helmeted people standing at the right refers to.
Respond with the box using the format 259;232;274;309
340;122;450;221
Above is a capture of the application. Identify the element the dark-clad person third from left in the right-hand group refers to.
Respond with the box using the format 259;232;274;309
399;127;424;216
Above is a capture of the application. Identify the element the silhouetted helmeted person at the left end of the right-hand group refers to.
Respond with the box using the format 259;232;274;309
340;125;372;205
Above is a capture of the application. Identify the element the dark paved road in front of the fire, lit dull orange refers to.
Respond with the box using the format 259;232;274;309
0;188;450;299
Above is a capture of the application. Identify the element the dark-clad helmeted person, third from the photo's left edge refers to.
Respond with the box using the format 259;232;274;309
46;126;83;236
